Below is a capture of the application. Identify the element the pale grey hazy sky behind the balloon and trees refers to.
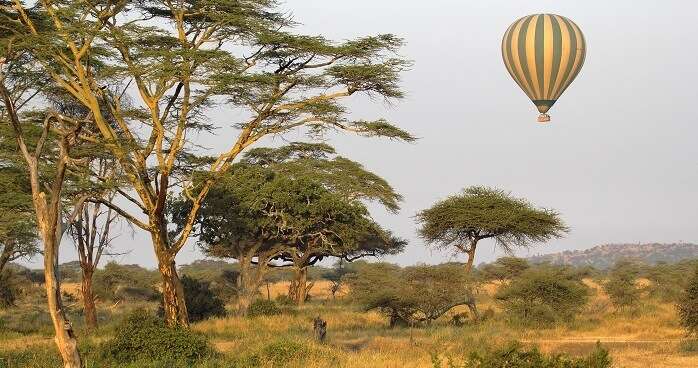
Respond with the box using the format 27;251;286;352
23;0;698;267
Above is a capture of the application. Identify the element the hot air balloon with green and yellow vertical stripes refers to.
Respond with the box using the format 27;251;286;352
502;14;586;123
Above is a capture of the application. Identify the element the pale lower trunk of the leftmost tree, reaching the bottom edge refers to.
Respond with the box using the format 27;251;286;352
41;230;82;368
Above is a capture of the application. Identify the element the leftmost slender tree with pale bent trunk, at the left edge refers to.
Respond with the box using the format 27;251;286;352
0;10;90;362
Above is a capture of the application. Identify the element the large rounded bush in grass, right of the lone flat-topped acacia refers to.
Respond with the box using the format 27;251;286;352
495;266;588;327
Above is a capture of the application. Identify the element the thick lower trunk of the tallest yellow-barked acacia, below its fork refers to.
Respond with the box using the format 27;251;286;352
157;251;189;327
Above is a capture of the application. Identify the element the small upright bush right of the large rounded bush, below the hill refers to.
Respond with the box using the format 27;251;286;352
603;261;642;309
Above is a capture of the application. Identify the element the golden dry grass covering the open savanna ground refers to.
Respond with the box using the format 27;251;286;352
0;280;698;368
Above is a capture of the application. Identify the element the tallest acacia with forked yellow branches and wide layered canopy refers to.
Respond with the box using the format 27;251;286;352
8;0;414;326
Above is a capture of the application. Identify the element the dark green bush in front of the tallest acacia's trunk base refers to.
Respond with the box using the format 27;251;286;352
100;310;214;365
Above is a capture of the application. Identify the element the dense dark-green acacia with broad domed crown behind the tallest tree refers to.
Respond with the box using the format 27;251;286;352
172;143;404;314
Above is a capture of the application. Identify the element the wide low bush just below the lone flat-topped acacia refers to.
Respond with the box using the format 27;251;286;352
347;263;473;326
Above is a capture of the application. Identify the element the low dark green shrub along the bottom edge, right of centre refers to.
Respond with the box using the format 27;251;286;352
440;342;612;368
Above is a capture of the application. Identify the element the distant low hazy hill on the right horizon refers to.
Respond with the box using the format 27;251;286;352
527;243;698;269
